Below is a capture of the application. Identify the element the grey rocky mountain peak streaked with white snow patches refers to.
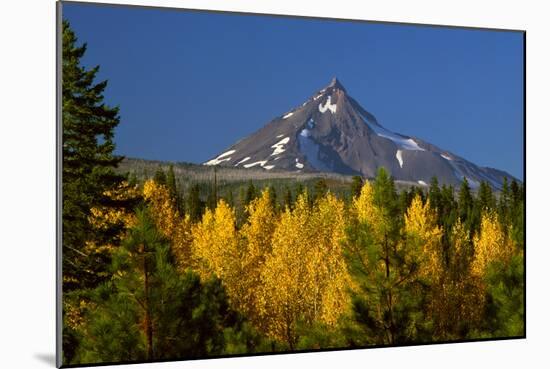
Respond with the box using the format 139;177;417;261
204;78;513;189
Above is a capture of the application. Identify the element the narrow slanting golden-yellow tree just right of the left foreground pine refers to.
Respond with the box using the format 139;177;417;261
143;180;193;271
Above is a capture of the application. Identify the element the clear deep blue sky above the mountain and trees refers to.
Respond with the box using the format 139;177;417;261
63;3;523;179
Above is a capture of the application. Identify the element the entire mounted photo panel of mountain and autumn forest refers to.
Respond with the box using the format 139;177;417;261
57;1;526;367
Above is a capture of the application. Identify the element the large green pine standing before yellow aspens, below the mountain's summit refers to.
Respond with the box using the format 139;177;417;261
346;168;434;344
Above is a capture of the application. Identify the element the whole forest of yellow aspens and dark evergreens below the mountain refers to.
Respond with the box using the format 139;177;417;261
62;22;525;365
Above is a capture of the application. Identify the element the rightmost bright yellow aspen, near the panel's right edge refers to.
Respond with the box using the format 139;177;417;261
472;212;514;276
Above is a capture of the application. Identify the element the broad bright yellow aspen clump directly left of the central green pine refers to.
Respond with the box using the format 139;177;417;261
259;193;347;350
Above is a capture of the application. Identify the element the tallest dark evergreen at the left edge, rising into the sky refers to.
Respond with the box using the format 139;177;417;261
62;21;125;292
